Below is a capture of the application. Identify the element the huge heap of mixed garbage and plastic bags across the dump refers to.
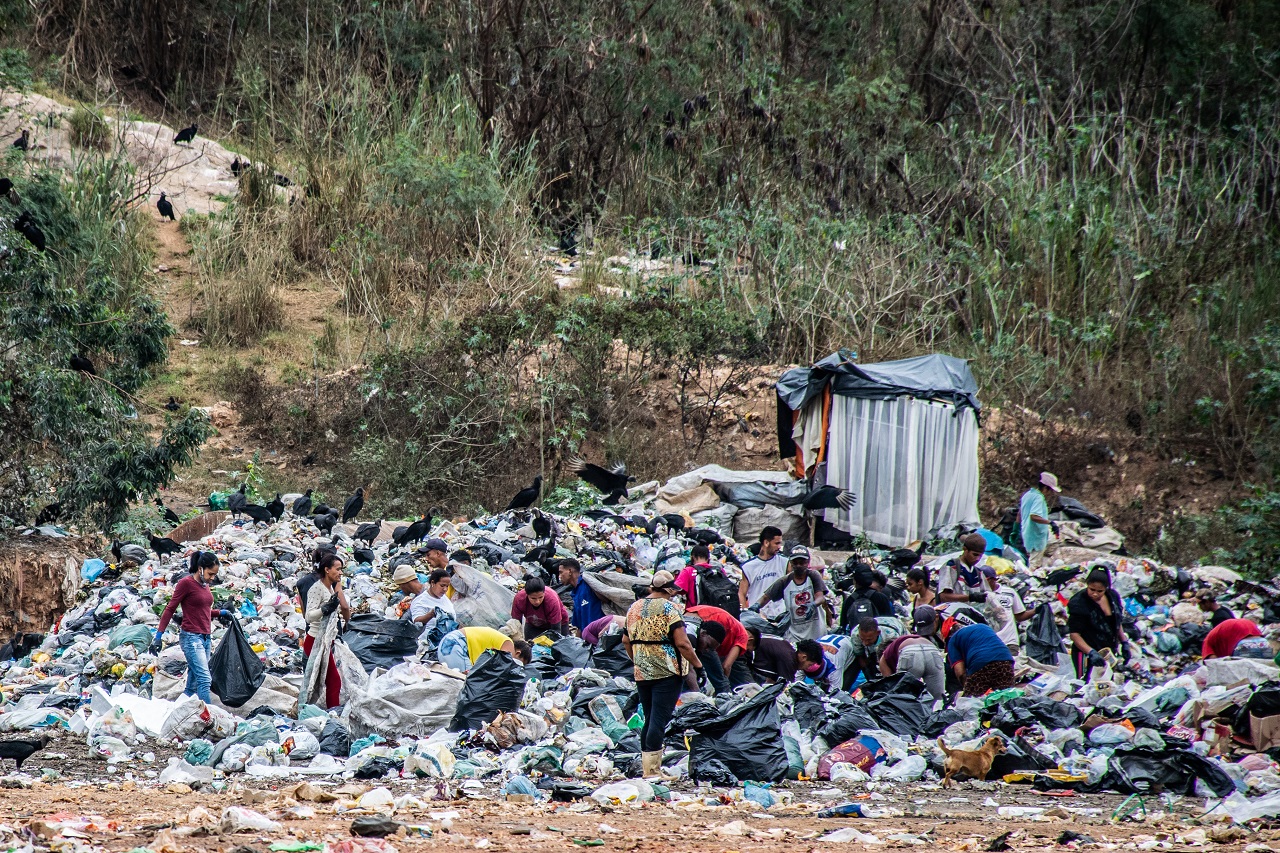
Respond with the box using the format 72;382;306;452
0;458;1280;824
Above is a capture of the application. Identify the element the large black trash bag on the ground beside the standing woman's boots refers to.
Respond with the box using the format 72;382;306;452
667;684;788;781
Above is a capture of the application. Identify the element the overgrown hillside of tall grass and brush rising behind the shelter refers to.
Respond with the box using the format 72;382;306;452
0;0;1280;568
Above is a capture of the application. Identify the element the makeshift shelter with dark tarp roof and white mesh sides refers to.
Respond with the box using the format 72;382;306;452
777;351;980;546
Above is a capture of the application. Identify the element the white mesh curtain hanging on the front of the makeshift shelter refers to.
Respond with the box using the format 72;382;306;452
824;396;978;547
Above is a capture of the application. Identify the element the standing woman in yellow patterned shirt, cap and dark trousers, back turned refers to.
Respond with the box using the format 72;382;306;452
622;571;707;776
